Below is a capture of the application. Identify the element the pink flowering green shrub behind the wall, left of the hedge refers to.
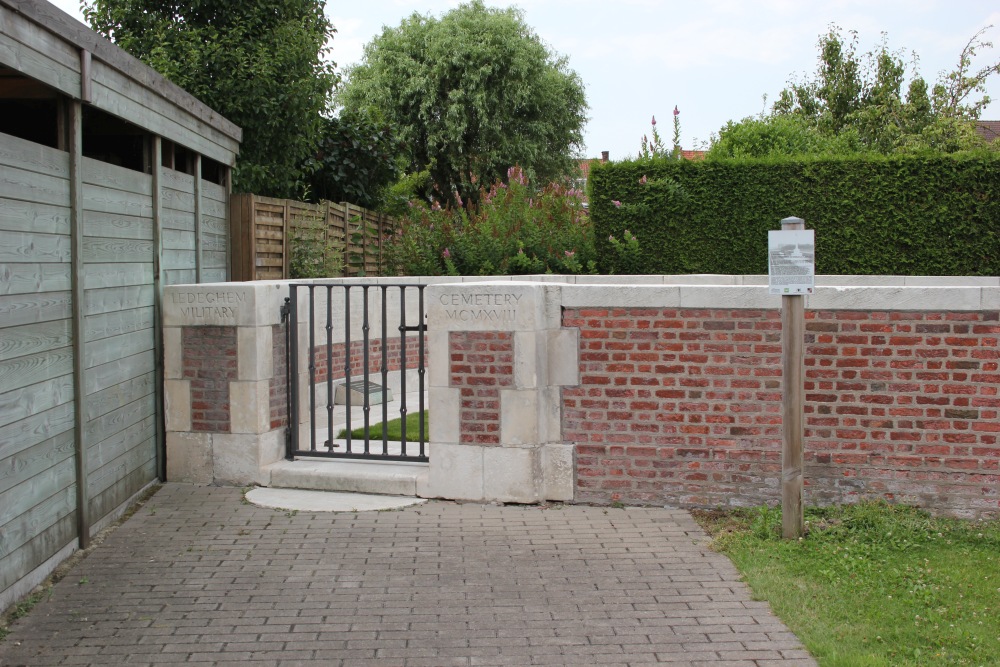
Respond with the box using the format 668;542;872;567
386;167;596;276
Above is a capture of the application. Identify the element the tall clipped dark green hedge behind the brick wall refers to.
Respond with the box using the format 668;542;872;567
589;154;1000;276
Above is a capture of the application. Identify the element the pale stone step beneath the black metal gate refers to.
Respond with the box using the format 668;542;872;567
269;459;427;497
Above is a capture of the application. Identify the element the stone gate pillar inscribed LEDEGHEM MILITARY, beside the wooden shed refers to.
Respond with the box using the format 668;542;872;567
163;281;288;485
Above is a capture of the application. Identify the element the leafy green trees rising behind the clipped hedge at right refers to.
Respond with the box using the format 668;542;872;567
709;26;1000;157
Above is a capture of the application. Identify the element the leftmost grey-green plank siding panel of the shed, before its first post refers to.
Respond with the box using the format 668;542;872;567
0;130;76;591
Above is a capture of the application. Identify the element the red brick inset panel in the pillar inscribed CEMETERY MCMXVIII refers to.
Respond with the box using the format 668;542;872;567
448;331;514;445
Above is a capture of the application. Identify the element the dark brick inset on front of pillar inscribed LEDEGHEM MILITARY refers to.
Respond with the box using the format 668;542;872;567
181;327;238;433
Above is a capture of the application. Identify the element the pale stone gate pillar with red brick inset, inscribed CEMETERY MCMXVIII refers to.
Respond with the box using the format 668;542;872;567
426;282;579;503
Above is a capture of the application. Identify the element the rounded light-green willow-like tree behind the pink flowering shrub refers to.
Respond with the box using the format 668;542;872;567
338;0;587;204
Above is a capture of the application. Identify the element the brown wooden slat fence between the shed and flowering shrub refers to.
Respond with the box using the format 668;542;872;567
229;194;397;280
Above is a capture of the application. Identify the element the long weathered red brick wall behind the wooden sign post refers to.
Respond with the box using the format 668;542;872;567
563;308;1000;516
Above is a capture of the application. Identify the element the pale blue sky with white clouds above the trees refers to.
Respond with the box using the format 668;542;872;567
47;0;1000;160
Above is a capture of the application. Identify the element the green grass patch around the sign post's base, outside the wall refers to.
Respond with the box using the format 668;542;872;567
697;503;1000;667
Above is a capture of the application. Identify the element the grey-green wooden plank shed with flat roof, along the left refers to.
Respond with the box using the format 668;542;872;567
0;0;241;609
